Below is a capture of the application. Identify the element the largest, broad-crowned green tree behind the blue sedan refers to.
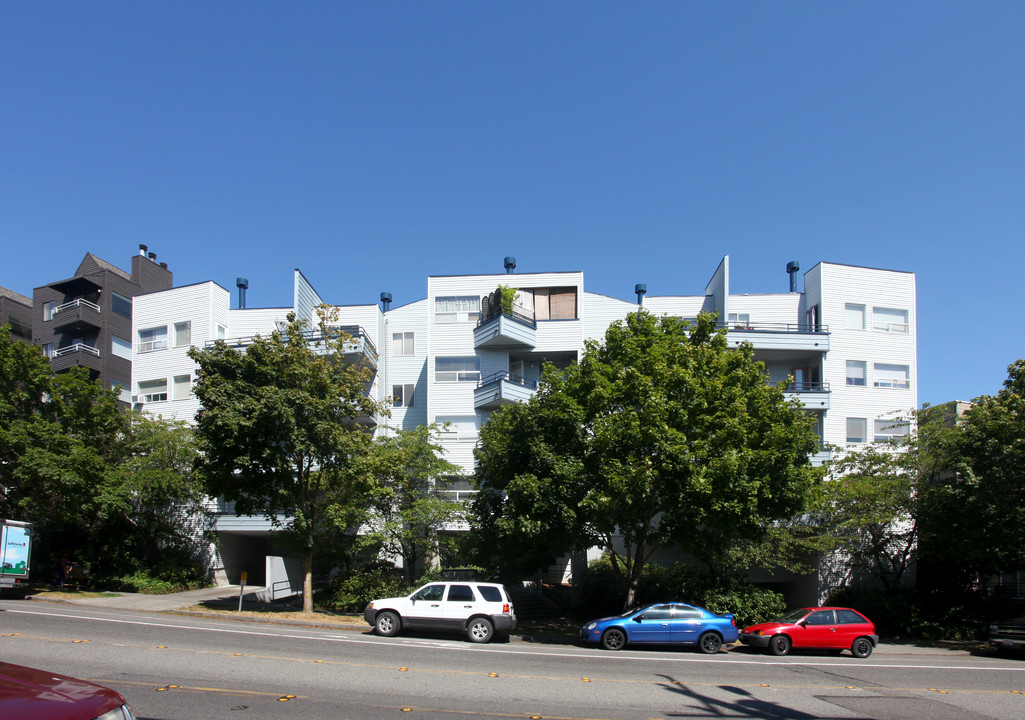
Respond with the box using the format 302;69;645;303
474;312;818;605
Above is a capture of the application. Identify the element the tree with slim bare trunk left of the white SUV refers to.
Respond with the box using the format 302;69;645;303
189;309;383;611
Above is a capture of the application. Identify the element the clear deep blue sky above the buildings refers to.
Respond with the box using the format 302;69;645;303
0;0;1025;404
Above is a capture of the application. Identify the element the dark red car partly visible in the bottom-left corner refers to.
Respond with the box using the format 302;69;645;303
0;663;124;720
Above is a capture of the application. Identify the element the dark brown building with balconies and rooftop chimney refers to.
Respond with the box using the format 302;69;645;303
32;245;173;402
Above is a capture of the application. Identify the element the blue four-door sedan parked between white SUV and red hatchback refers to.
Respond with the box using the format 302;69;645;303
580;602;737;654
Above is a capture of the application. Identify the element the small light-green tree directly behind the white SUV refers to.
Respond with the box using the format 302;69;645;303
372;425;462;583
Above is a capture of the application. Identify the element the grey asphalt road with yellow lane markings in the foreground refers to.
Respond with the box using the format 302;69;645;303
0;601;1025;720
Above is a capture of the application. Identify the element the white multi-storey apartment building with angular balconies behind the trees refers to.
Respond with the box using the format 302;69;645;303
132;256;917;598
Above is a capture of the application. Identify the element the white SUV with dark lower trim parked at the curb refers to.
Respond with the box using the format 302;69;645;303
363;582;516;642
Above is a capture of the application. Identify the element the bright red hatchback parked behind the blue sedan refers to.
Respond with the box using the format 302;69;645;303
740;607;879;657
